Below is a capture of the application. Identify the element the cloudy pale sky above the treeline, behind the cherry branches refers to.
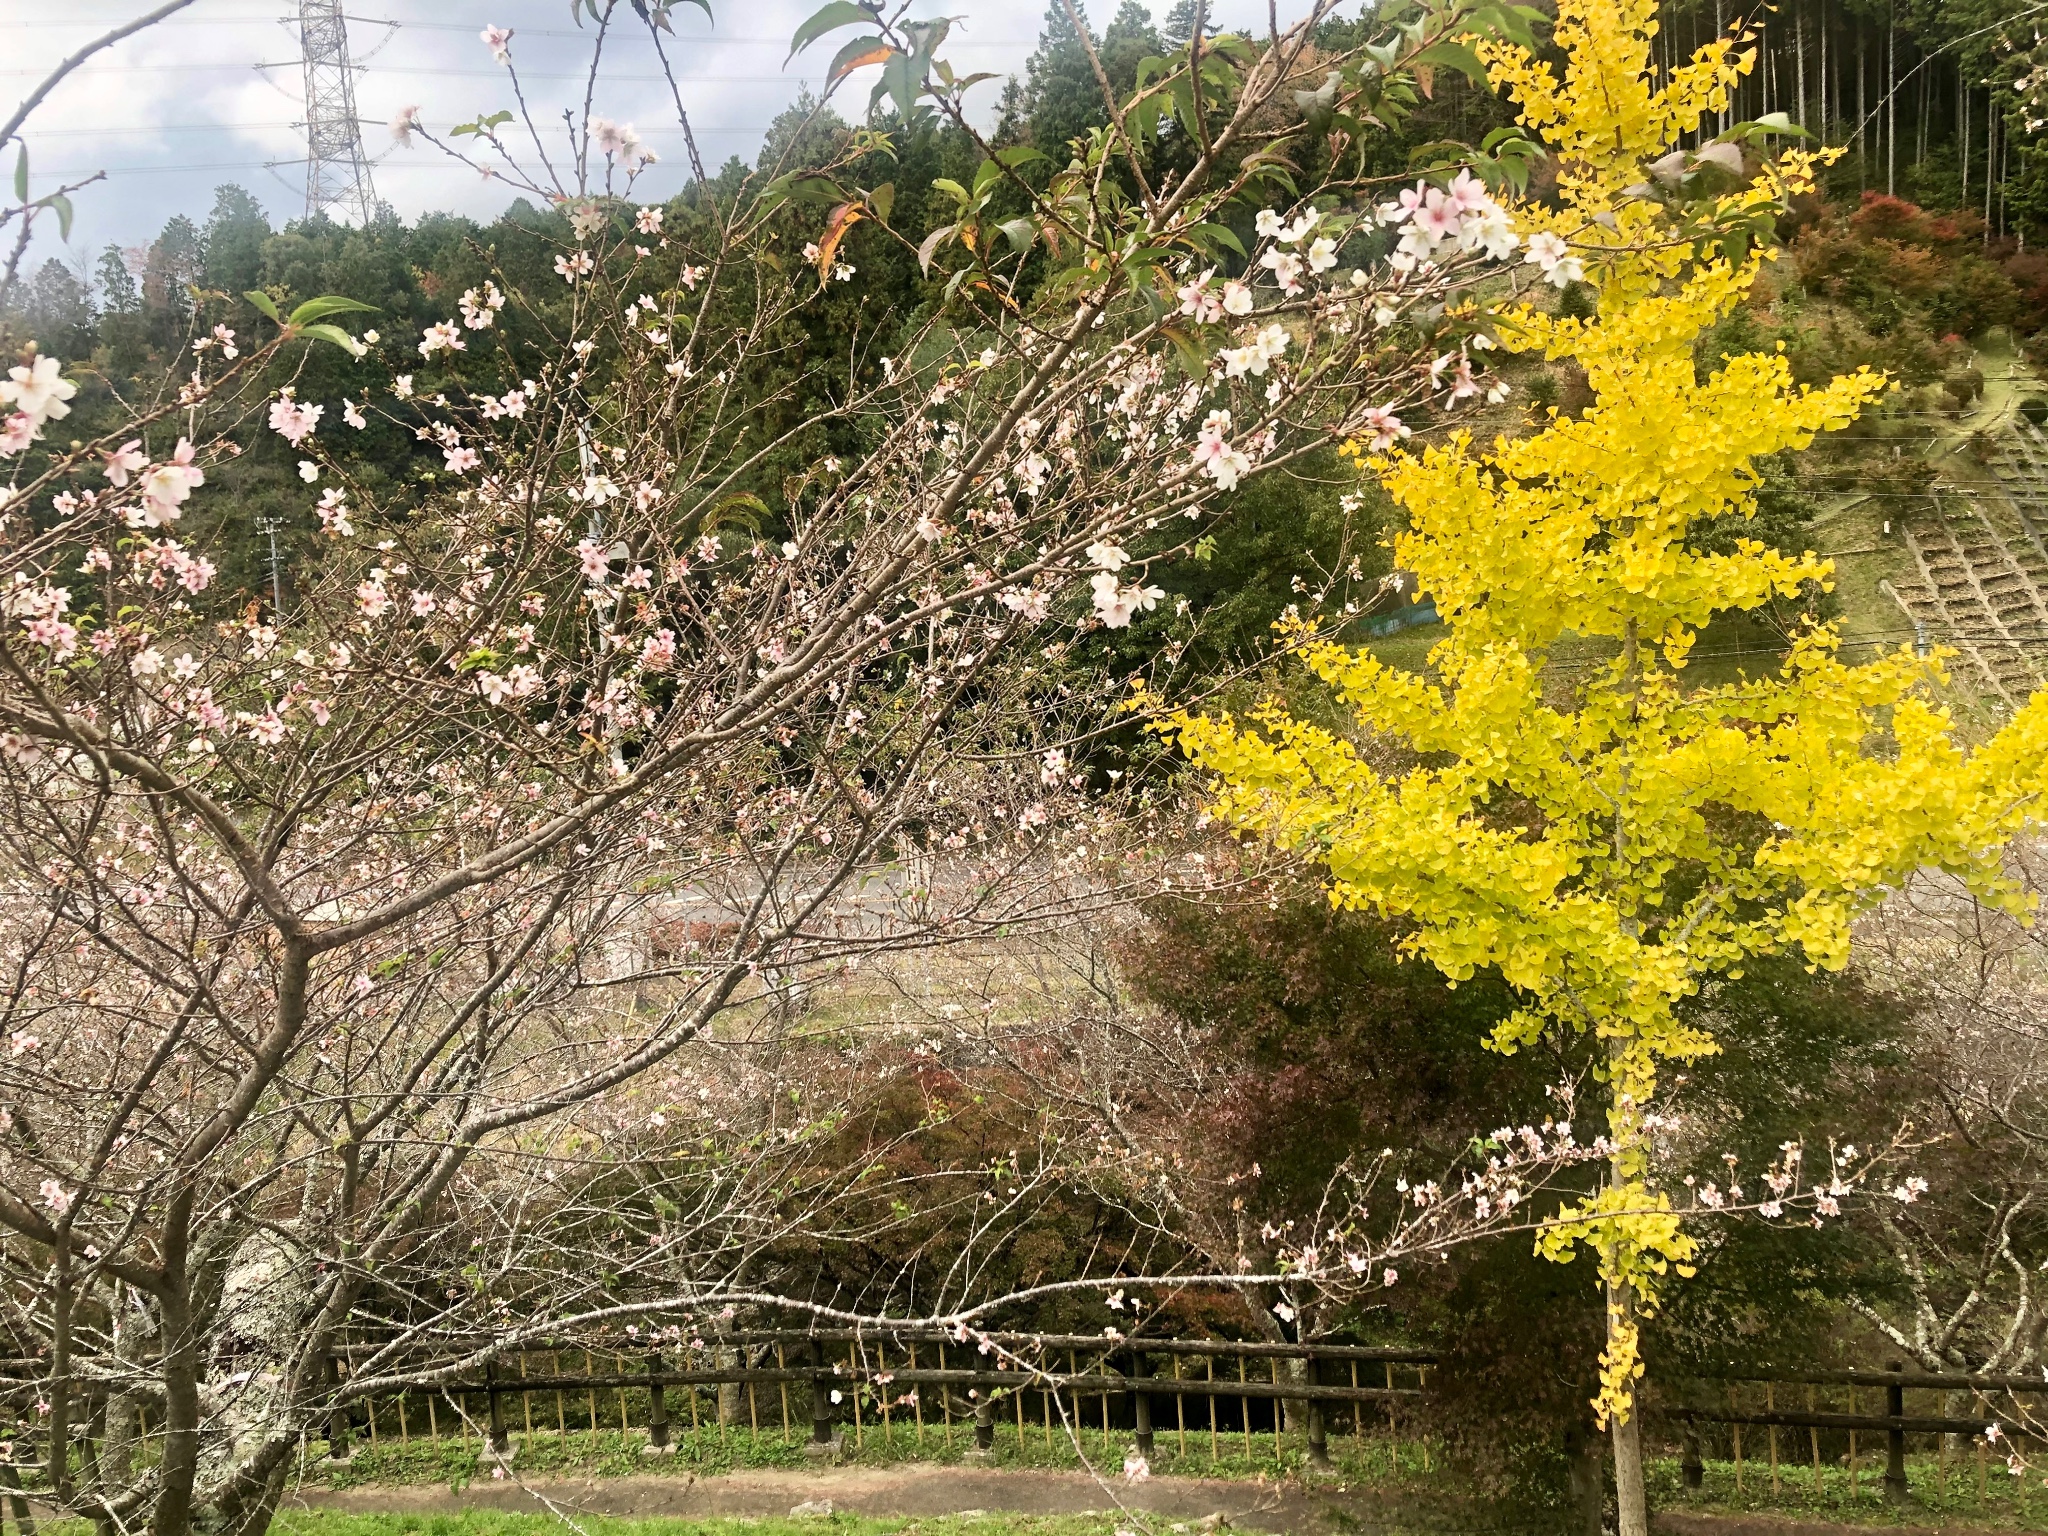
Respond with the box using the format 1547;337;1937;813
0;0;1298;282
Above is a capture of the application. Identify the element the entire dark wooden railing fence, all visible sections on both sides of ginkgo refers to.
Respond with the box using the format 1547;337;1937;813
0;1319;2048;1501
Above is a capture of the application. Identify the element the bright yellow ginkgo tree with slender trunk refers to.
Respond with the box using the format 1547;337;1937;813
1171;0;2048;1536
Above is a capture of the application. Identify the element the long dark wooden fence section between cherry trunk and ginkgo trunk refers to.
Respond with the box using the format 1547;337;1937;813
256;1329;1436;1464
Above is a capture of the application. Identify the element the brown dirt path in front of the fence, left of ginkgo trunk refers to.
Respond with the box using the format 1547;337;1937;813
295;1466;1460;1536
